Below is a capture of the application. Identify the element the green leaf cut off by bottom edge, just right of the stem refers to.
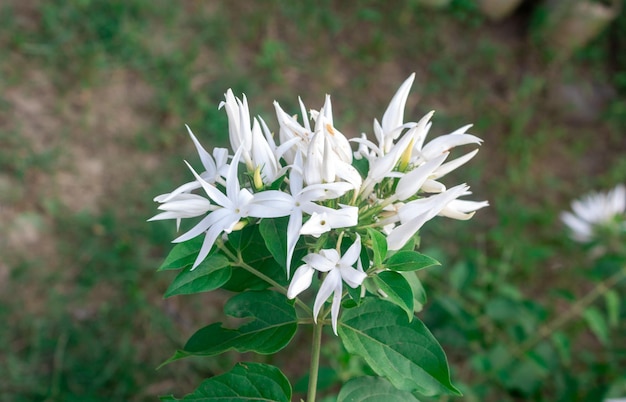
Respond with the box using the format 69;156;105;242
337;377;419;402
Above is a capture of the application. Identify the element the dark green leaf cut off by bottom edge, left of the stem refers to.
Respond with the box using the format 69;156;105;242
161;363;291;402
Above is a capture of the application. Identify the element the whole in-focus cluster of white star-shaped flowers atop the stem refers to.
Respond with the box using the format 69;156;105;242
152;75;488;332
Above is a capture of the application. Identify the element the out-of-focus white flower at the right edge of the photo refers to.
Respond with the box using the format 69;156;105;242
561;184;626;243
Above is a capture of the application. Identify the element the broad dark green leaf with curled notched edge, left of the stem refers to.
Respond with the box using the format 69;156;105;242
166;290;298;363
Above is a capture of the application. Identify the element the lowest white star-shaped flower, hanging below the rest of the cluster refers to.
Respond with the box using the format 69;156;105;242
287;235;367;335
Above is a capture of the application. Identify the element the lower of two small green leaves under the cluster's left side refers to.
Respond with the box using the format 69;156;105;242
165;254;232;298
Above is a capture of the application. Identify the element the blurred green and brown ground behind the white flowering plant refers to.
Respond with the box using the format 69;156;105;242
0;0;626;401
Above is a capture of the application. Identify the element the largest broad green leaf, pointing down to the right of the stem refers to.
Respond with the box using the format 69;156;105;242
339;298;461;396
